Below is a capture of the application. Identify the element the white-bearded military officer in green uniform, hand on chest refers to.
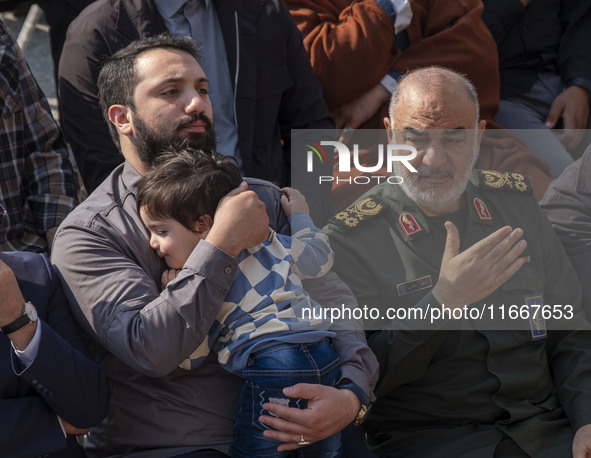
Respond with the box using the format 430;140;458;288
325;67;591;458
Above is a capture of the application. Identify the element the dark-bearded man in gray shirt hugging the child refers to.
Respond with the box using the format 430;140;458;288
52;35;377;458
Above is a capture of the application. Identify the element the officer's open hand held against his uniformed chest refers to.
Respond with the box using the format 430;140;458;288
433;221;527;308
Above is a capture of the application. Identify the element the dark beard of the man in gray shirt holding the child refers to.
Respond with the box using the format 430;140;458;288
131;112;216;165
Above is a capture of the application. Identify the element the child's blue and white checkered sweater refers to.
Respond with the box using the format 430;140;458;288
180;213;334;376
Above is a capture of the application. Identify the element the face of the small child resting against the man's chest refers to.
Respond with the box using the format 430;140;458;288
140;208;202;269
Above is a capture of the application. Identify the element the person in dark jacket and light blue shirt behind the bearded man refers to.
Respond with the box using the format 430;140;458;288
59;0;334;224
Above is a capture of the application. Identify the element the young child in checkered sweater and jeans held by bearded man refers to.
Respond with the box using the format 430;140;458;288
136;150;340;458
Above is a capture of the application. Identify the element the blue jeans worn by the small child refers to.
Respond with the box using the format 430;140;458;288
232;339;342;458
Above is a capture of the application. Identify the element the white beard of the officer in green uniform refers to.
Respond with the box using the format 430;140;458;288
393;143;479;215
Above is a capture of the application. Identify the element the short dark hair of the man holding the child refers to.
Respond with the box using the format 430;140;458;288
97;33;198;148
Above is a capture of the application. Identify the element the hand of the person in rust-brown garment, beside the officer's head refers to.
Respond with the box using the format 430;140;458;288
330;84;391;129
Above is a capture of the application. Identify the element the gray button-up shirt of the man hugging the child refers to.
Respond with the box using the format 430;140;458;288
52;162;377;458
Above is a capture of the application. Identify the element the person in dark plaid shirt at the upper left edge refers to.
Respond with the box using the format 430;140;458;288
0;19;78;254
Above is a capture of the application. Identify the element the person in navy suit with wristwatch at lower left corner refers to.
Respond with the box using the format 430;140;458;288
0;199;109;458
